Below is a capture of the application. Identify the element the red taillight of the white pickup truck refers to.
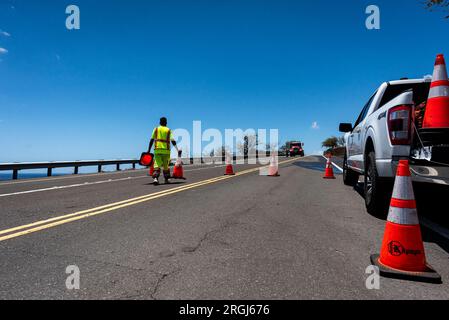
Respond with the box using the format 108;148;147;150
388;105;412;145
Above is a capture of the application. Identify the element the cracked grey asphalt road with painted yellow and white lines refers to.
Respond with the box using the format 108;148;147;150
0;157;449;299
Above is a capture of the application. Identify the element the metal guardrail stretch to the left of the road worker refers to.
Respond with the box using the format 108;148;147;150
0;159;139;180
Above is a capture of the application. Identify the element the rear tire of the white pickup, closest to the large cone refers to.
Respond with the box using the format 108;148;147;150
364;151;392;218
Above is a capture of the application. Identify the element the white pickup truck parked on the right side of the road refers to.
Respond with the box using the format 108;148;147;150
340;78;449;215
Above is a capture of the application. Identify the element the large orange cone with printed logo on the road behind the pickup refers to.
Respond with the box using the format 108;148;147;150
371;160;441;283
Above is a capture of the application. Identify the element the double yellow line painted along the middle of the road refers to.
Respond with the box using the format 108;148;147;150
0;159;300;242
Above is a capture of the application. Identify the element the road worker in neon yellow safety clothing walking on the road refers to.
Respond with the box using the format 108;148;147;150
148;117;180;185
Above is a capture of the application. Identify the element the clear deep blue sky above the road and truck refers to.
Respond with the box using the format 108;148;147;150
0;0;449;162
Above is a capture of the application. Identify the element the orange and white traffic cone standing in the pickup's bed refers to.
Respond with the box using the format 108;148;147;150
423;54;449;129
